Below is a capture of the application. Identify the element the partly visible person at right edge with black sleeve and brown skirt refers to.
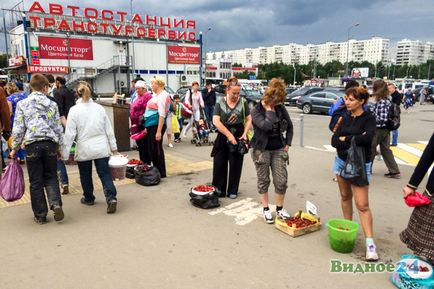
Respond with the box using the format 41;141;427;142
400;134;434;264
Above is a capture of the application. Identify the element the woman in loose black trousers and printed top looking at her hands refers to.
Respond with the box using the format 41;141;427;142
211;77;252;199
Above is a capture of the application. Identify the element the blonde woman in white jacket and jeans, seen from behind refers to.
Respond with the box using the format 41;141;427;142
63;81;118;214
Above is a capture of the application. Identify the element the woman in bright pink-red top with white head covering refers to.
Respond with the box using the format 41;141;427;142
130;80;152;164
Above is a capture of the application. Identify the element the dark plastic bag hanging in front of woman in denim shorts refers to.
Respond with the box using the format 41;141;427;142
340;137;369;187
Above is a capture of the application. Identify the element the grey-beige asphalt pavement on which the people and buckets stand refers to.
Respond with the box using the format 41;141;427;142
0;105;434;289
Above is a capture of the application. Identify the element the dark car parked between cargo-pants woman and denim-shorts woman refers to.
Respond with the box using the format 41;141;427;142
297;90;345;114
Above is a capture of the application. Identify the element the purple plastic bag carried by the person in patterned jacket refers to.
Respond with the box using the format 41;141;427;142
0;159;25;202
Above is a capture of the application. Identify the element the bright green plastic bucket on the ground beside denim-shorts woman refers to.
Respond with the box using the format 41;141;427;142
327;219;359;253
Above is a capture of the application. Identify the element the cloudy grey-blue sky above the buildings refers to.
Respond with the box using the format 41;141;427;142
0;0;434;51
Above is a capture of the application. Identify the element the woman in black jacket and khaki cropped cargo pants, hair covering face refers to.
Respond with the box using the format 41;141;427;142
251;78;293;224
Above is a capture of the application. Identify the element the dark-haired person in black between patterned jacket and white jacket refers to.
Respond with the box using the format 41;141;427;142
54;76;75;195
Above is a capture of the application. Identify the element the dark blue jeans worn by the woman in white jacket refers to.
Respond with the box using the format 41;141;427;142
77;158;117;203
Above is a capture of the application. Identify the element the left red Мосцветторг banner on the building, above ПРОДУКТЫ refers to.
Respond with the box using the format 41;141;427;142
38;36;93;60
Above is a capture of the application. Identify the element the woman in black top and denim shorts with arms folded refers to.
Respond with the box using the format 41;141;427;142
332;87;378;261
